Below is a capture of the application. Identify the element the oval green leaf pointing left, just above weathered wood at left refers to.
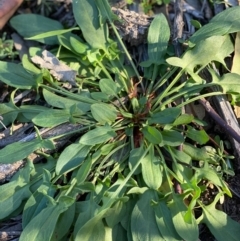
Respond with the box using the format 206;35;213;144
32;109;72;127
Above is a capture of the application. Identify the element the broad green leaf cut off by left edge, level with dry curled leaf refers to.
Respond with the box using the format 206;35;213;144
0;61;36;89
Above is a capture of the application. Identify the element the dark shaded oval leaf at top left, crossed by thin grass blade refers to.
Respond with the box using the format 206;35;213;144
10;14;63;45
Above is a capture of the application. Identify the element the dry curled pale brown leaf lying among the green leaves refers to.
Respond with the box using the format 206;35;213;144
31;50;77;86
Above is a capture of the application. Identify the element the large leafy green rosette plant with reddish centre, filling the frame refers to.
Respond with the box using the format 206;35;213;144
0;0;240;241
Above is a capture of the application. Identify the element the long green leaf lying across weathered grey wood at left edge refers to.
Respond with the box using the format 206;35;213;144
0;139;55;163
